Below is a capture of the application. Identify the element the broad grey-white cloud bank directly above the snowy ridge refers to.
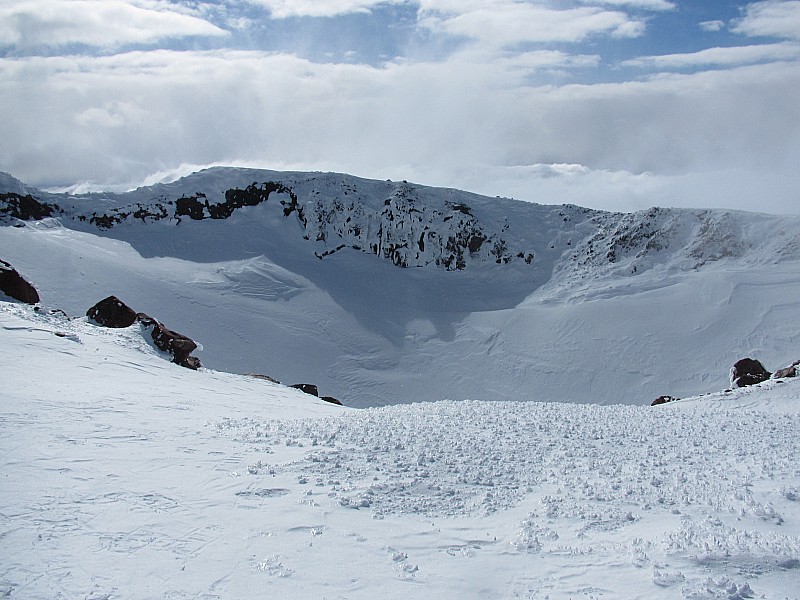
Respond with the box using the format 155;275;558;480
0;50;800;212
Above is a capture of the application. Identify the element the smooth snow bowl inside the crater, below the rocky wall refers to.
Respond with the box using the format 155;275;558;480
0;219;800;407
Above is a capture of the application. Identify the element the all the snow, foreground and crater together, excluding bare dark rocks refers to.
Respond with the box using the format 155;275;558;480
0;169;800;600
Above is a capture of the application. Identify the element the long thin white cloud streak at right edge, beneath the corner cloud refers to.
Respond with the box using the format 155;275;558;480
621;42;800;69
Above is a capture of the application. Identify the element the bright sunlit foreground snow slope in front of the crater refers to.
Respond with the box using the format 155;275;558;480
0;300;800;600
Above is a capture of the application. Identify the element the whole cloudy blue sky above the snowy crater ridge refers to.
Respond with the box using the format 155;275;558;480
0;0;800;213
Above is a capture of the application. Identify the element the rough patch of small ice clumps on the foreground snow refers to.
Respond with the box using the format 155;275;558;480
216;401;800;529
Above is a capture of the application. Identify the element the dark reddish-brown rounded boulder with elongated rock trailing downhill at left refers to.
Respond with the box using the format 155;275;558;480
86;296;202;370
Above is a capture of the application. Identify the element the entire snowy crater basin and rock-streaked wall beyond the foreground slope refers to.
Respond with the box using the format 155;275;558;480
0;168;800;407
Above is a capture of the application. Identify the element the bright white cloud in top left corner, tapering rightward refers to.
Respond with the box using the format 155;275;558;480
0;0;227;52
